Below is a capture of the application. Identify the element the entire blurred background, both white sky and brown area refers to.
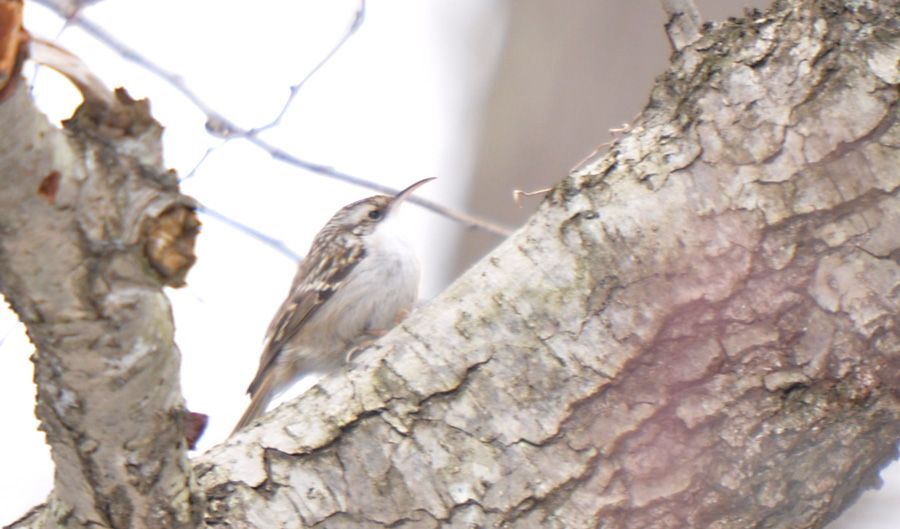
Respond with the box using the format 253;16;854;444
0;0;900;529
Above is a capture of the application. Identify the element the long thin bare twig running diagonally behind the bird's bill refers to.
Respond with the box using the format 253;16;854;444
34;0;512;237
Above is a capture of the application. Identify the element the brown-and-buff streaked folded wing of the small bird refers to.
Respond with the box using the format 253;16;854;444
247;240;365;396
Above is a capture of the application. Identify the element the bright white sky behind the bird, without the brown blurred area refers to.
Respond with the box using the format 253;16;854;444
0;0;900;529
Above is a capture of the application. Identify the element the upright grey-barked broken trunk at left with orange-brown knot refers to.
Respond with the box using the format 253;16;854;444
0;83;202;528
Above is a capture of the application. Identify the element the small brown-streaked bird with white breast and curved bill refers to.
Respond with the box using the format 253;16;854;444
232;178;434;433
